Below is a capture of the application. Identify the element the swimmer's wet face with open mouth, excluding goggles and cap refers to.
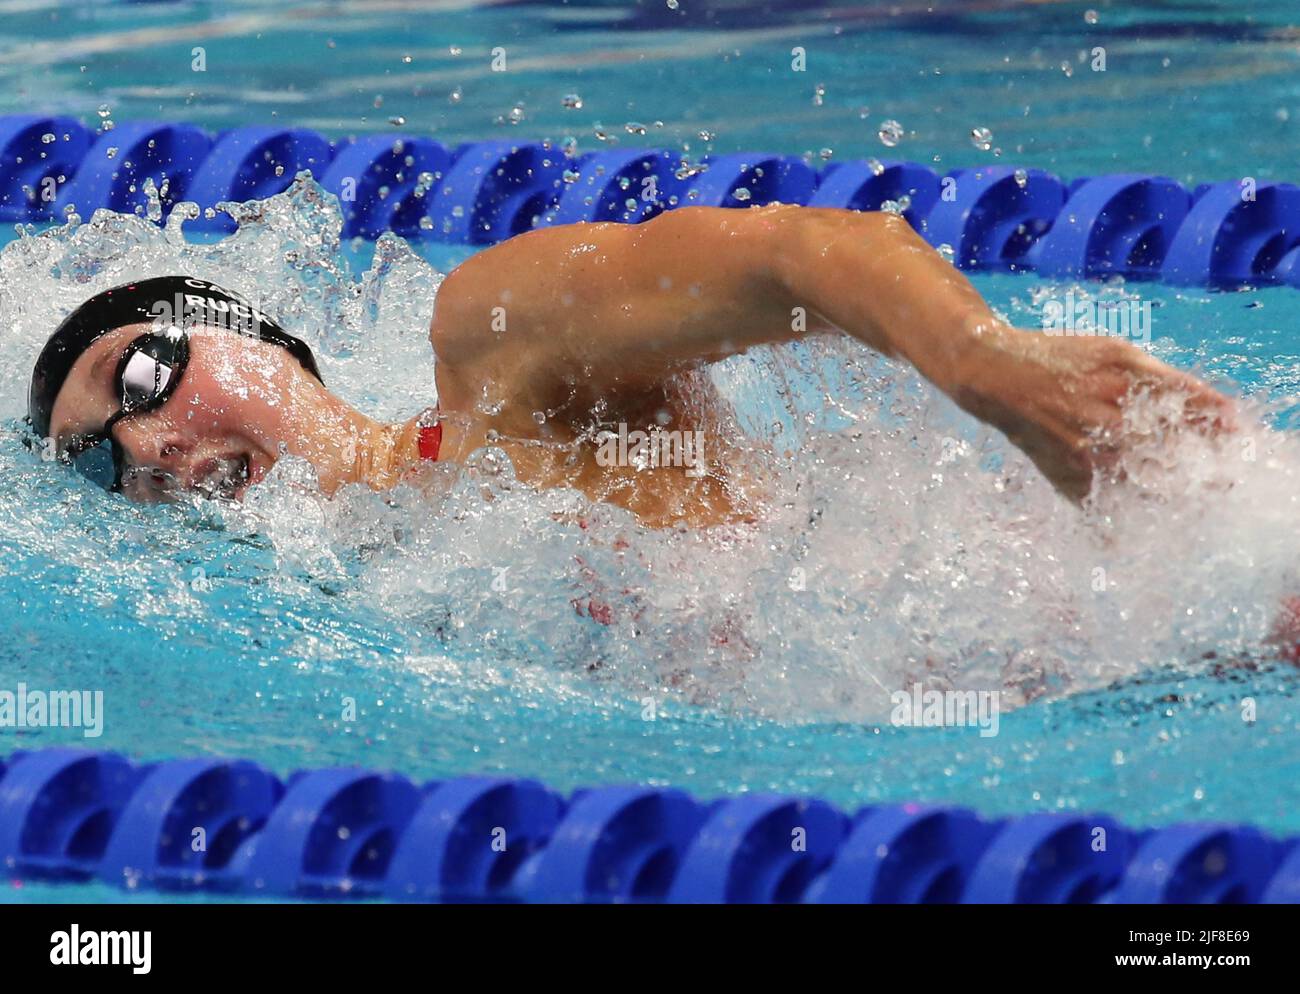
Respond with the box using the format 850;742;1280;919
49;324;319;502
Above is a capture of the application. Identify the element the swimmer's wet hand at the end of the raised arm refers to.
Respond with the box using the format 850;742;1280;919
948;325;1232;500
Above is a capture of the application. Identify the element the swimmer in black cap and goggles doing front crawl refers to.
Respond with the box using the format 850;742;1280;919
29;204;1230;526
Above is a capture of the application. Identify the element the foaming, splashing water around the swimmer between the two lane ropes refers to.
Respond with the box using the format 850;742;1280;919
0;179;1300;847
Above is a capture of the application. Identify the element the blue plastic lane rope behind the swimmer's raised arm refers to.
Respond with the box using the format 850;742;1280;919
0;114;1300;288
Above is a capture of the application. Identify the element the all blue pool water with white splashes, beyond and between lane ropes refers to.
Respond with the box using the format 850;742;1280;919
0;0;1300;899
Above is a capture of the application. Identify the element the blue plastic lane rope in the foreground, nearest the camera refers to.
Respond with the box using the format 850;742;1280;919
0;748;1300;904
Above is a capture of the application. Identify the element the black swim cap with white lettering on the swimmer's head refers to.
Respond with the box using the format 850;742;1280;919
27;275;324;438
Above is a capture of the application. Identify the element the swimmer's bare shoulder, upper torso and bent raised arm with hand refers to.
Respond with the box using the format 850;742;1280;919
430;205;1229;525
